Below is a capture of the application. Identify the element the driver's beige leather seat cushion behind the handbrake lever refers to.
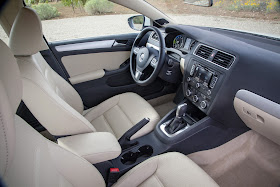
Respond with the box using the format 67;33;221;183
85;93;160;139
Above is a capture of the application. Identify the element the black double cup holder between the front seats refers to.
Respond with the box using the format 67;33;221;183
121;145;153;165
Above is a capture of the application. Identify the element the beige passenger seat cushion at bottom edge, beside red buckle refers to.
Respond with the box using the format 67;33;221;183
113;152;218;187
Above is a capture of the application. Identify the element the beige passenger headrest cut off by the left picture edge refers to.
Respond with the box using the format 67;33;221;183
0;40;22;114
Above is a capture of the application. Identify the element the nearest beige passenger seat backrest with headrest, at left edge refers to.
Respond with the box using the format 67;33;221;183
0;41;105;187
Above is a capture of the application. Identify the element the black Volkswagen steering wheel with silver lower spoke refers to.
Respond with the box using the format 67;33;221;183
130;27;165;86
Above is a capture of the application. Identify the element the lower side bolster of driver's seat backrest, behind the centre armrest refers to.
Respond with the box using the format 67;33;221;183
22;78;95;136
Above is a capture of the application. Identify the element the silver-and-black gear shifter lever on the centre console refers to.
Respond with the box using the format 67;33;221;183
166;103;188;134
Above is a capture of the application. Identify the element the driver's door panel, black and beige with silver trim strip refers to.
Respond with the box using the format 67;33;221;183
46;34;178;108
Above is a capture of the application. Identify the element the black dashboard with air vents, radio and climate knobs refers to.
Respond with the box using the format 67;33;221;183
145;25;280;128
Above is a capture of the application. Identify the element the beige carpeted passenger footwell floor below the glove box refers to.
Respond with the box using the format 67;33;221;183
188;131;280;187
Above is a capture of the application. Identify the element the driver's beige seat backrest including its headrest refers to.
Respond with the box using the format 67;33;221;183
9;7;95;136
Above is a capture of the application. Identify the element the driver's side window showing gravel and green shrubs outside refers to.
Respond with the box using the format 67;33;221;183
25;0;140;42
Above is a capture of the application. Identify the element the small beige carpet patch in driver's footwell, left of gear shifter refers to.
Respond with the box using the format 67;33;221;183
148;94;176;118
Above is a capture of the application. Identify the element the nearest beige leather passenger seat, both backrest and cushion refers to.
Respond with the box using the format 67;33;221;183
0;40;217;187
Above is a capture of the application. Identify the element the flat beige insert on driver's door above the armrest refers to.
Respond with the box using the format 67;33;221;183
61;51;130;80
